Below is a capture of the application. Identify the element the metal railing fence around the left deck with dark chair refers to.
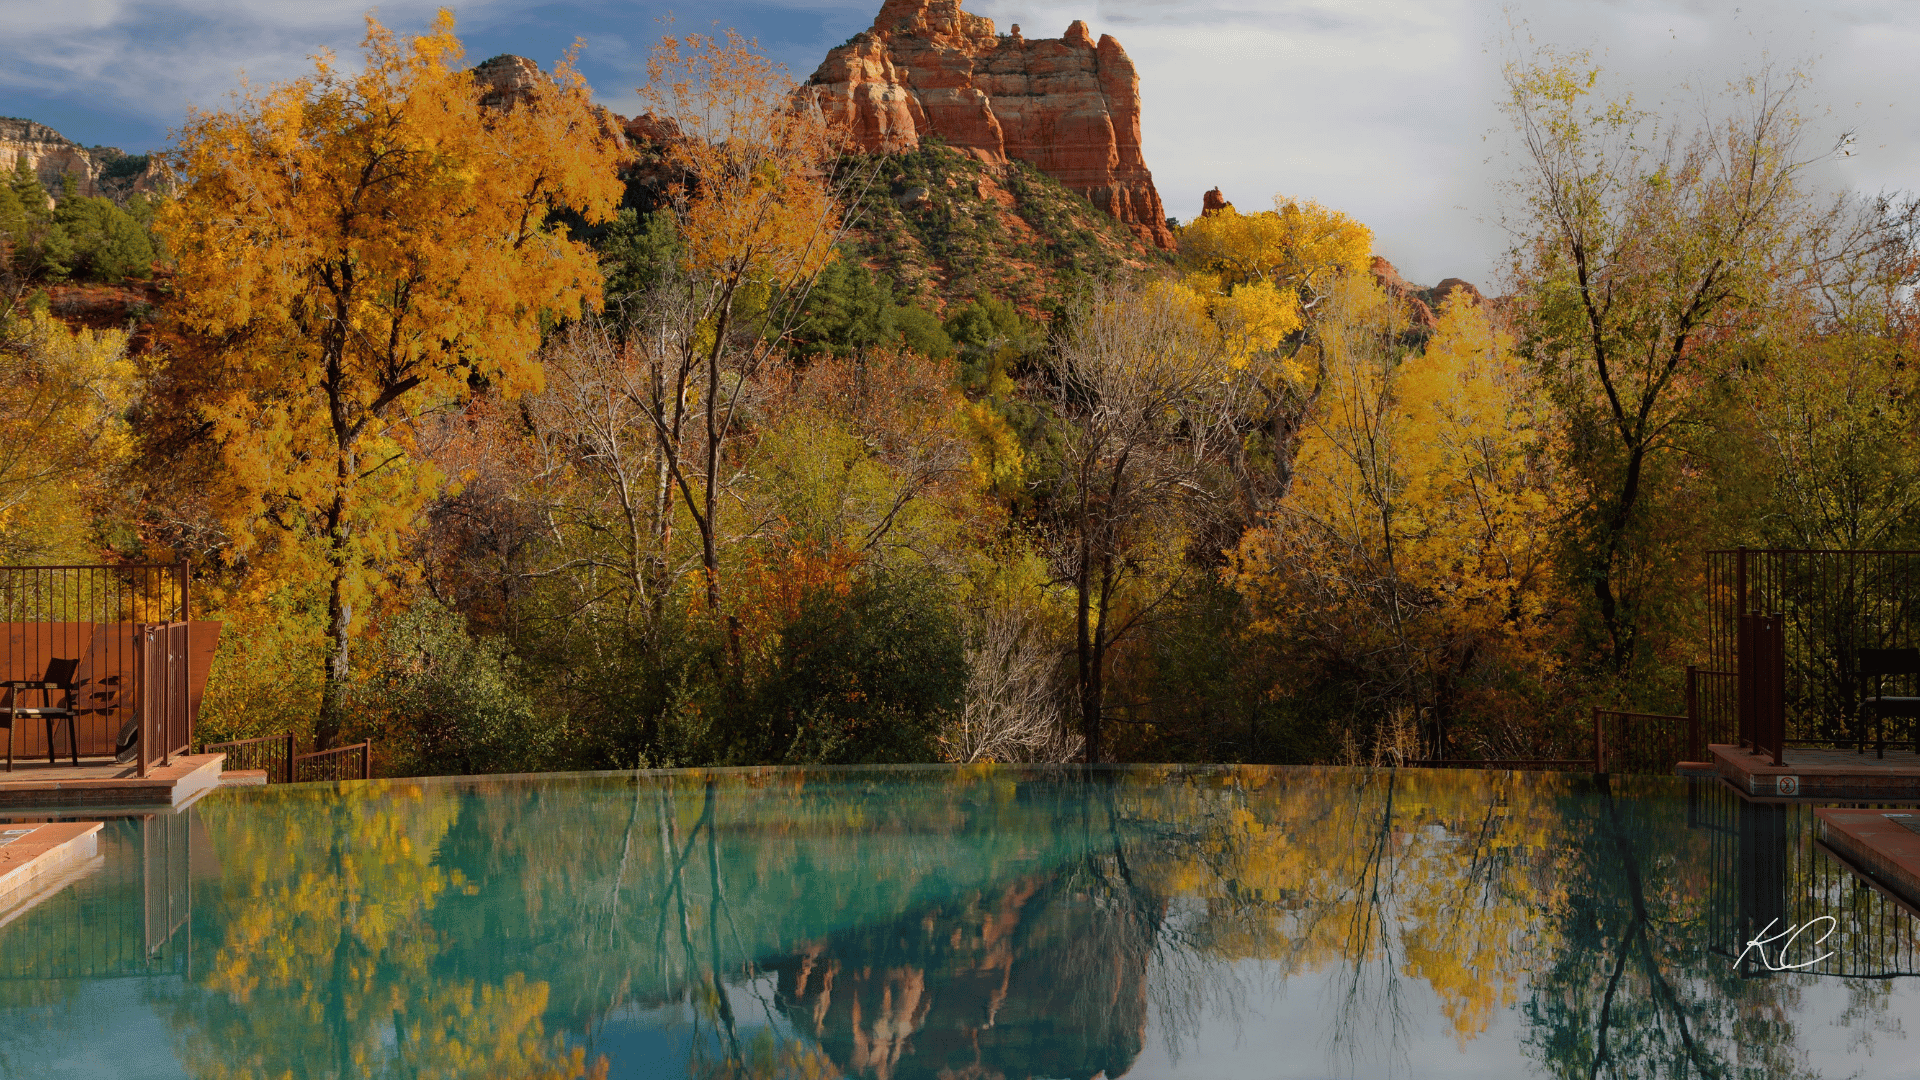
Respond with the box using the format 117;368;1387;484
0;561;196;776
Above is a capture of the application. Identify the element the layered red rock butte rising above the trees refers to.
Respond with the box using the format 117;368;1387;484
806;0;1173;248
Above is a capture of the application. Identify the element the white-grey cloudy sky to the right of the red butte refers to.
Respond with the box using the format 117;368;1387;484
968;0;1920;284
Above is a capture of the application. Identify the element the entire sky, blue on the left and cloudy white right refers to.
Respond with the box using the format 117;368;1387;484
0;0;1920;290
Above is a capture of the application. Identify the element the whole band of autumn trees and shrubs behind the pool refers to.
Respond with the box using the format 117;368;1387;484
0;15;1920;774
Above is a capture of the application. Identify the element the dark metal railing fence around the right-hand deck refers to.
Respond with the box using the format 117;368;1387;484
1701;548;1920;749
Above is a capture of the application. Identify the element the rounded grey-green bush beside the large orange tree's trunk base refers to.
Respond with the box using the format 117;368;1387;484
355;598;563;774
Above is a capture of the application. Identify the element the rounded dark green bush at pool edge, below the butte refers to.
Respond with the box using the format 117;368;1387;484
737;578;966;765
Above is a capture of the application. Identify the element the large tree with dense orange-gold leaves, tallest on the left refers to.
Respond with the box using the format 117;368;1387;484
161;12;620;746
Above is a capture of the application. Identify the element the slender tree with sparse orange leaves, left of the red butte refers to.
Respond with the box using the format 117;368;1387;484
626;31;843;634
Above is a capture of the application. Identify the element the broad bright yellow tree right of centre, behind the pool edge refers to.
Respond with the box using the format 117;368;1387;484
1231;277;1561;749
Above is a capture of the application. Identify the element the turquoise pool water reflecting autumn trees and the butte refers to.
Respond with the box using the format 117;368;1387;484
0;767;1920;1080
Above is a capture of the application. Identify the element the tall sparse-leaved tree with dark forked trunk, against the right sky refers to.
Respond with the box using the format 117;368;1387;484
1505;52;1872;671
